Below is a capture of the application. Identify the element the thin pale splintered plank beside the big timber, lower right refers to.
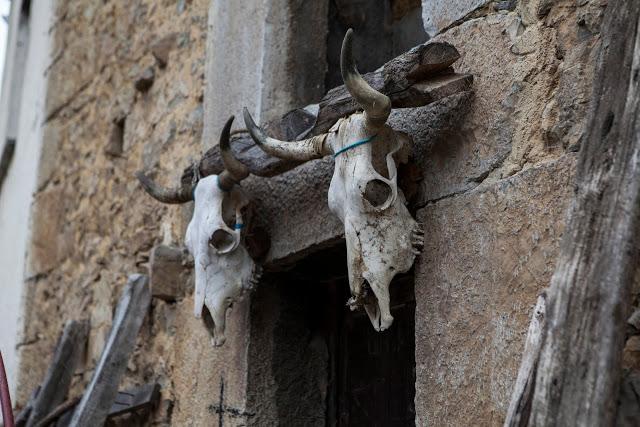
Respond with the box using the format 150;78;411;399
504;293;547;427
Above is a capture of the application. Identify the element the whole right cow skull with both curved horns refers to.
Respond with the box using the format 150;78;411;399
244;30;423;331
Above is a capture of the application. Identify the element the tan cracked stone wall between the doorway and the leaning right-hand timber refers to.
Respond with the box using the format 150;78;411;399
416;0;606;425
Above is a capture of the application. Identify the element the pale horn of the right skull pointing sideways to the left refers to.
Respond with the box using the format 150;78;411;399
243;107;331;162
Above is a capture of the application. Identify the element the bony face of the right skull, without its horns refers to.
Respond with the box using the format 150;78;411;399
327;114;422;331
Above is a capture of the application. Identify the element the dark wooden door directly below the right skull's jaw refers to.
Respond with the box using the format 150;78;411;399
329;277;415;427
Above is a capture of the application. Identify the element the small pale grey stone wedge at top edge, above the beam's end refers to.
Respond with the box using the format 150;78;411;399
422;0;490;37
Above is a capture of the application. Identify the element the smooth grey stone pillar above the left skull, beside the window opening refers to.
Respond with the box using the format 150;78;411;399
202;0;328;148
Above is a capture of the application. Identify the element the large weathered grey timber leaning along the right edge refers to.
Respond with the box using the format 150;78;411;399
516;0;640;426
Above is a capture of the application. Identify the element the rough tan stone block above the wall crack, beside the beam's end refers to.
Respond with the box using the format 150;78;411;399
412;14;562;204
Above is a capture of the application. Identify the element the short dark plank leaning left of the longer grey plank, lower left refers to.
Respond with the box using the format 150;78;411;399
26;320;89;427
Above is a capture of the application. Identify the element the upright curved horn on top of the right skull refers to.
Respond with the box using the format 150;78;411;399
340;28;391;128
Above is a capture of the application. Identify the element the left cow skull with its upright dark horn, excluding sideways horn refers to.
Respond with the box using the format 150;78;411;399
185;117;260;346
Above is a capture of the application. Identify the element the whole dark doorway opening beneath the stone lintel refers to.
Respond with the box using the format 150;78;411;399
248;243;415;427
